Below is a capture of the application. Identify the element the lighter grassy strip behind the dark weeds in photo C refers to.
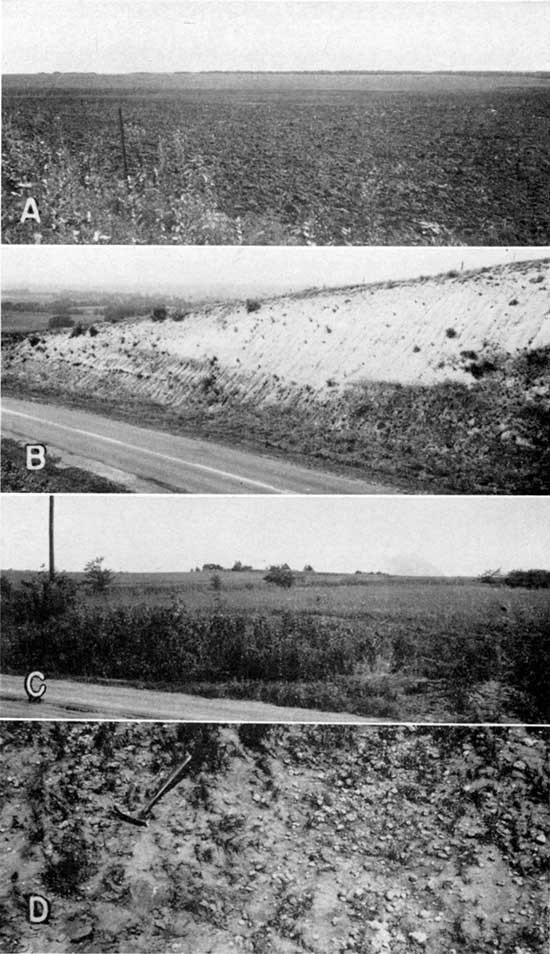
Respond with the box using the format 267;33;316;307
27;570;550;612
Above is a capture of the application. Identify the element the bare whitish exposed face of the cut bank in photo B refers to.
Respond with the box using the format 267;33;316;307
6;261;550;407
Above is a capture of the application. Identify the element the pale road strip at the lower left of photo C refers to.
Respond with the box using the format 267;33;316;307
0;675;372;722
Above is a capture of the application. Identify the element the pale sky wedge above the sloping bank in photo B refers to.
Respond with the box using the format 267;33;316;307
2;245;550;298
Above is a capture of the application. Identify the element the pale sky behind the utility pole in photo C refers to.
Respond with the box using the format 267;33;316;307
2;494;550;575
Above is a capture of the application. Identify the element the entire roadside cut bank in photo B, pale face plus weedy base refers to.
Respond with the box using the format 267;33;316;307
3;261;550;493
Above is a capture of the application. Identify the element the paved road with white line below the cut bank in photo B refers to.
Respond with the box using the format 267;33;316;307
2;397;394;494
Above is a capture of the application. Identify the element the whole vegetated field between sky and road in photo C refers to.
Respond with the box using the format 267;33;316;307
3;571;550;721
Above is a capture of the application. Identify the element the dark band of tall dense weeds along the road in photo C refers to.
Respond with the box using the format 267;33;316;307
4;604;365;683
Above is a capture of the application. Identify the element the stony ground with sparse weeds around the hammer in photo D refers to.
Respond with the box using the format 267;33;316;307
0;723;550;954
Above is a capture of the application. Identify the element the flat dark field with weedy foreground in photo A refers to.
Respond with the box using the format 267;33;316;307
2;76;550;245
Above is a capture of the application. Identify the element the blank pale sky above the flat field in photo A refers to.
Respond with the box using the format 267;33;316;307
2;0;550;73
